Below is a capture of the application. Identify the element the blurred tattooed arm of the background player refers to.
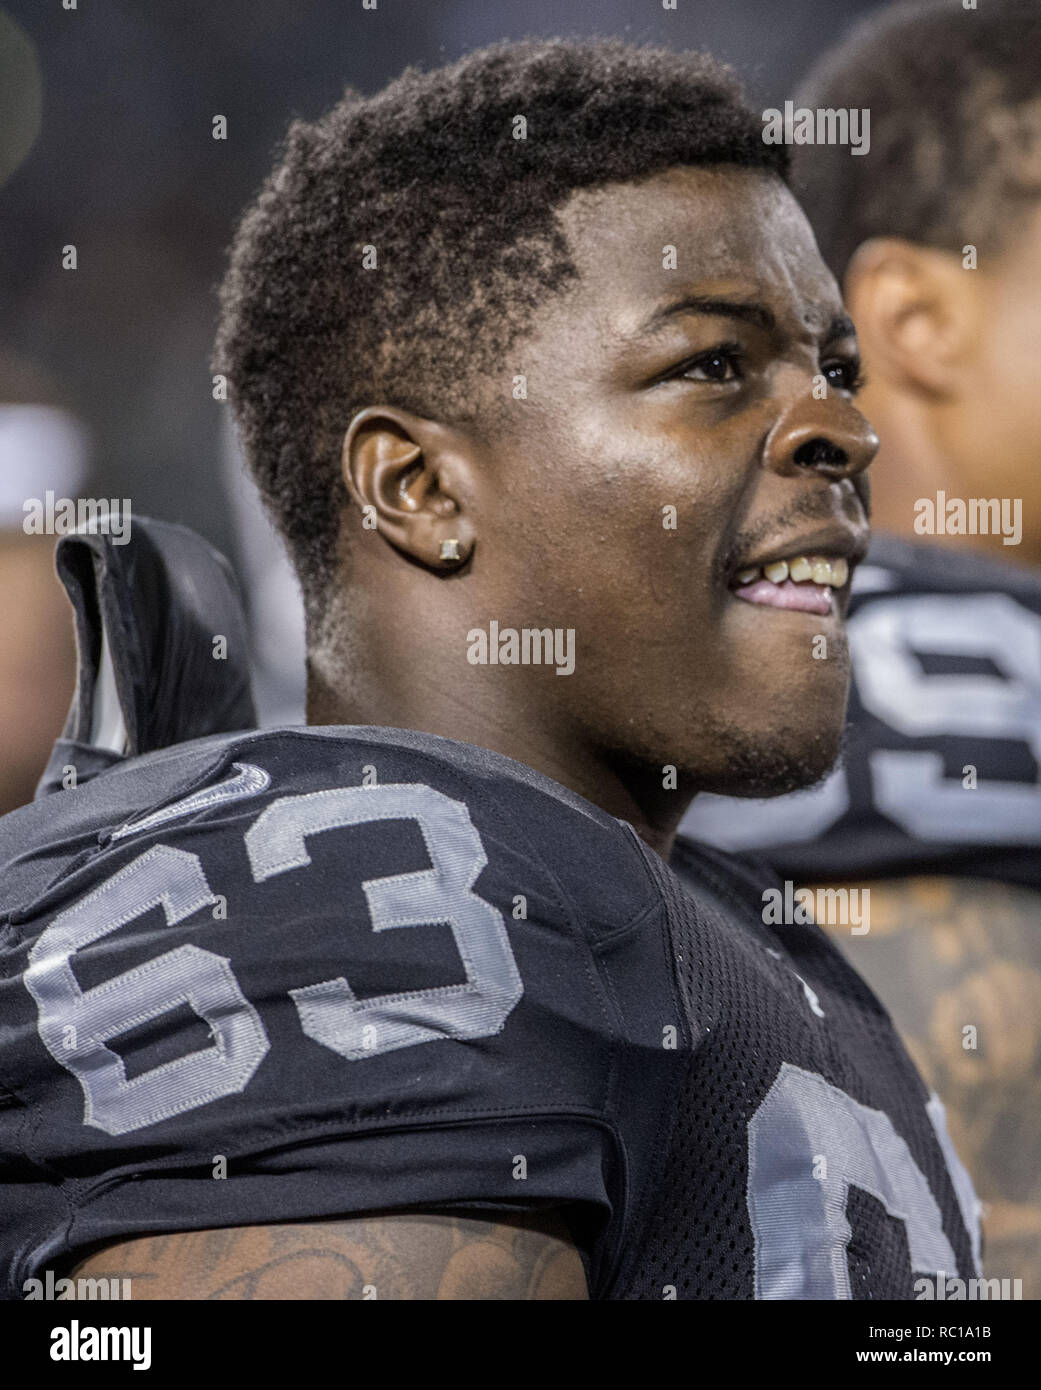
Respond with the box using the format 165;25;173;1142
830;877;1041;1298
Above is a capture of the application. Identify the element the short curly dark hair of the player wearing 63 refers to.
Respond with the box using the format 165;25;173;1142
214;39;788;621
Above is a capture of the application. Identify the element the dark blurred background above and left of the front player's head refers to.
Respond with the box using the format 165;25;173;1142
0;0;877;553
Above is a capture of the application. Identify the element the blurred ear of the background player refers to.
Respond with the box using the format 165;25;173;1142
844;236;980;398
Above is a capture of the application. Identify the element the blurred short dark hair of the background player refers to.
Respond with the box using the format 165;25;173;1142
792;0;1041;282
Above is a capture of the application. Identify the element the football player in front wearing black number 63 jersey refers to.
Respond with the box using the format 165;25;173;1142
0;42;977;1300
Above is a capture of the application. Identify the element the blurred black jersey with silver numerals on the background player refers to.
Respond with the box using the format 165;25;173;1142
681;535;1041;888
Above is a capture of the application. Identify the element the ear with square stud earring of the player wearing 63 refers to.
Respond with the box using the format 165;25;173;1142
342;406;475;573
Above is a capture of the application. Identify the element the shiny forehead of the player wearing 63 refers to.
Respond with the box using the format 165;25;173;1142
559;167;841;334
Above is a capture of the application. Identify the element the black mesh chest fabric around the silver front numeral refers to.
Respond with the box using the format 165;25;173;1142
612;848;973;1300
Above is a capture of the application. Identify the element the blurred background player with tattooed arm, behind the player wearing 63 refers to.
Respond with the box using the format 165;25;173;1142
685;0;1041;1297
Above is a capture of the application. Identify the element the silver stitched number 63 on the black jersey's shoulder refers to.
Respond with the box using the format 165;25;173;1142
24;784;523;1134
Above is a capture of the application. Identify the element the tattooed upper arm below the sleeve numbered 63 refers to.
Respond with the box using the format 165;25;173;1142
72;1212;588;1300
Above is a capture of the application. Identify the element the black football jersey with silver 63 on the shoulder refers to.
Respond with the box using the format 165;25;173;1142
0;728;978;1300
